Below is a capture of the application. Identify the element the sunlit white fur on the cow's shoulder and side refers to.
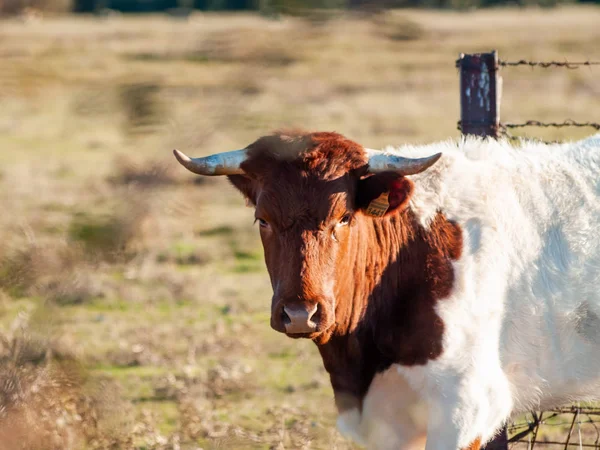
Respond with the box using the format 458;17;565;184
363;135;600;450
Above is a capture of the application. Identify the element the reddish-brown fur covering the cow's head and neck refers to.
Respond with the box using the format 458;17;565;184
230;132;462;410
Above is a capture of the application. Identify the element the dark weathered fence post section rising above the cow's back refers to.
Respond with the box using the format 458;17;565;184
457;50;502;138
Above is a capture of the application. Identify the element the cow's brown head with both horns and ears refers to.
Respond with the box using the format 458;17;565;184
175;132;441;339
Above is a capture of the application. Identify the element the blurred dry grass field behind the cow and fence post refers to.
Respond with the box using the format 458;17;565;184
0;7;600;450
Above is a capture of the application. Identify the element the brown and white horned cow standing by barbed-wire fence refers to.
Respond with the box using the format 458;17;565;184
175;131;600;450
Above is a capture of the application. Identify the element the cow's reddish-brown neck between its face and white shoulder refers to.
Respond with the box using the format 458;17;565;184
317;210;462;409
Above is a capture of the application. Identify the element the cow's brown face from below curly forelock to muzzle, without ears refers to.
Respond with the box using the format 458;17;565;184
247;172;356;337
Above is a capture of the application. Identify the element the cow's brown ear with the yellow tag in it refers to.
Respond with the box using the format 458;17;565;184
356;172;414;217
